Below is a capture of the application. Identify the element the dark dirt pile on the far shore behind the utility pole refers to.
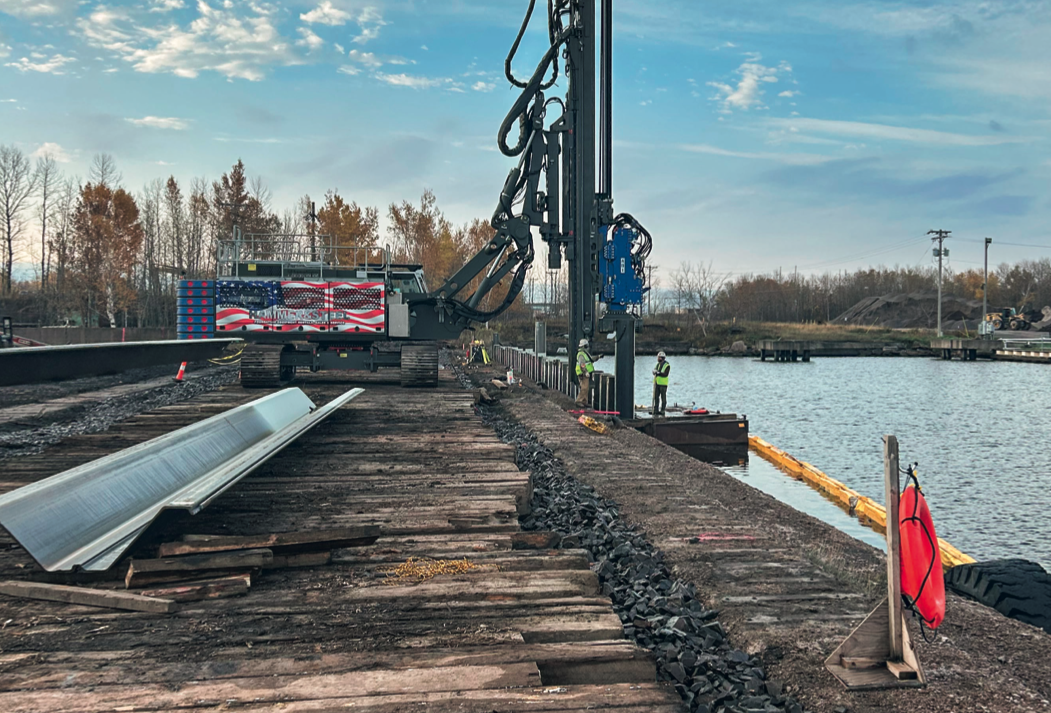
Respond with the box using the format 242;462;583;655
834;292;982;329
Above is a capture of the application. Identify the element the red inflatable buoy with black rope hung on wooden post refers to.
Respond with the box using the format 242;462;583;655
899;485;945;629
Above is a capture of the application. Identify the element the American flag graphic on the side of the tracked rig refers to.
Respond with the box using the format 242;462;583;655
215;280;387;332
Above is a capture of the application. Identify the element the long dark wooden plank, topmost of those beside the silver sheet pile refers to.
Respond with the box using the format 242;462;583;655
158;525;380;557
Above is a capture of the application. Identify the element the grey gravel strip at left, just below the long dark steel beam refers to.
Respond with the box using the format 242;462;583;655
0;365;238;461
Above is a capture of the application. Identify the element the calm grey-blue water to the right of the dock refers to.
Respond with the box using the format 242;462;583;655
636;355;1051;570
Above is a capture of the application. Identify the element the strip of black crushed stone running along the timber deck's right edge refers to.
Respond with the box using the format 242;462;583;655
456;369;803;713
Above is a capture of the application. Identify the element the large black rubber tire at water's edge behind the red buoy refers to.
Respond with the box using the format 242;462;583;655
945;559;1051;634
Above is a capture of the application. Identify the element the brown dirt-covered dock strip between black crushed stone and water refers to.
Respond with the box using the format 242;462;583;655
493;382;1051;713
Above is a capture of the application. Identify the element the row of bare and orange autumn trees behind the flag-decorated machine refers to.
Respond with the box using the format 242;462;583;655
0;146;502;327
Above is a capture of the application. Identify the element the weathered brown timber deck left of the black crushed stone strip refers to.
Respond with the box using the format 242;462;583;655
0;374;679;713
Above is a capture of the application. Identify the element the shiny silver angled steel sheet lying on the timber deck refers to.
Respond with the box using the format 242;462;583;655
0;388;363;572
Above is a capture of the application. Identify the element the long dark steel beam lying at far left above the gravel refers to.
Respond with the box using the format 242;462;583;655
0;339;240;386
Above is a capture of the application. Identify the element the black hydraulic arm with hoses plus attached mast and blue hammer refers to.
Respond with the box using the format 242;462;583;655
410;0;651;416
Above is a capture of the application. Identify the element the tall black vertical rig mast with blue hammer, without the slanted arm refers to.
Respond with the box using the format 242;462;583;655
493;0;652;417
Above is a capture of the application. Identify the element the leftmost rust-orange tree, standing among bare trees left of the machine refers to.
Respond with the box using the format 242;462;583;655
73;183;143;327
